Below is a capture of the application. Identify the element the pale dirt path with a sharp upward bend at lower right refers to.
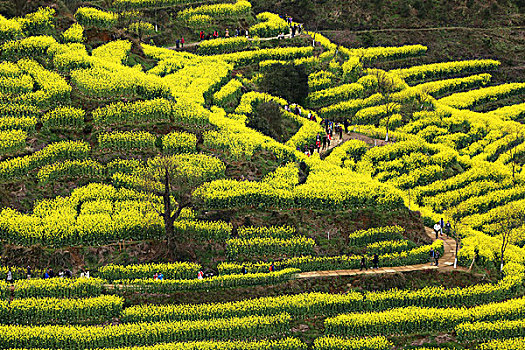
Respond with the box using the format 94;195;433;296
296;227;462;279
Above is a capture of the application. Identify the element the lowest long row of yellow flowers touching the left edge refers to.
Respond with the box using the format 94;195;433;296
0;313;291;350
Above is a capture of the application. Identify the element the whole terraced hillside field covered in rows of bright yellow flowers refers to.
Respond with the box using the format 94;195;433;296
0;0;525;350
